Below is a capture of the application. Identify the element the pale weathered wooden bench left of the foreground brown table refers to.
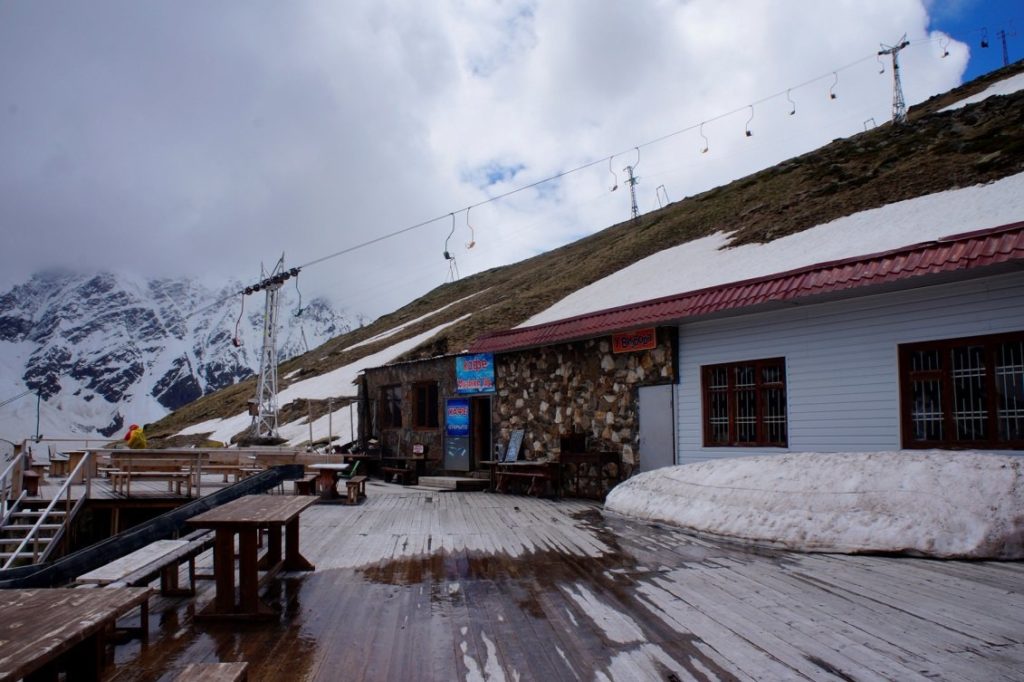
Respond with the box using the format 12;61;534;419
75;530;214;596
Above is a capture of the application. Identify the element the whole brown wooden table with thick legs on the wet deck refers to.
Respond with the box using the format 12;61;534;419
187;495;316;619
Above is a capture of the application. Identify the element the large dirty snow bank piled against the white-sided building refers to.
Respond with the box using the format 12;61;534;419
605;451;1024;559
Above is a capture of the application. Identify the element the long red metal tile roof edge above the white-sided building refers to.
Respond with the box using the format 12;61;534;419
470;221;1024;352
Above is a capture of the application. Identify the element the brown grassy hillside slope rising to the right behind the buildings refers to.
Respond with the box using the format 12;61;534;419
150;62;1024;437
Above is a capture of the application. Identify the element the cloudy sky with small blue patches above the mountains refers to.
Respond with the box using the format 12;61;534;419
0;0;1021;317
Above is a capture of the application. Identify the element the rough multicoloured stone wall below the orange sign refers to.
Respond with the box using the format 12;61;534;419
494;328;676;472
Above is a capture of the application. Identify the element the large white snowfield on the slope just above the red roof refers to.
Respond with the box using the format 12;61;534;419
519;173;1024;327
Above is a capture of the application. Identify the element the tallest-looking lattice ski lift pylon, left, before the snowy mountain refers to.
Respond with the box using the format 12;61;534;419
243;254;299;440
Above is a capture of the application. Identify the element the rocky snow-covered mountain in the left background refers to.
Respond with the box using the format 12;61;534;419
0;271;350;440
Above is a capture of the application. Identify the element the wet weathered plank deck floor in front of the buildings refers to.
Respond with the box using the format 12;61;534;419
75;481;1024;682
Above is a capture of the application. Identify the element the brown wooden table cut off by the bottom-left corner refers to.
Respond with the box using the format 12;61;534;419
0;588;153;682
